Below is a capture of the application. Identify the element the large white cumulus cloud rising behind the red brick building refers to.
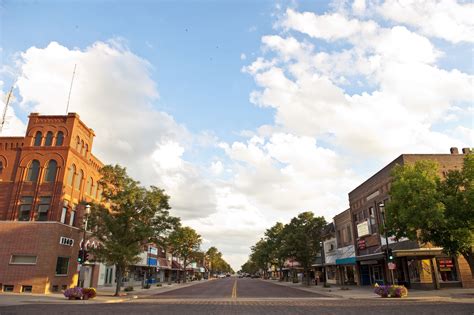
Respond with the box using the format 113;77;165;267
11;40;215;218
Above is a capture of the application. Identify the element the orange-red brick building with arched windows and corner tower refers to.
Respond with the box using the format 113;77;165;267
0;113;103;293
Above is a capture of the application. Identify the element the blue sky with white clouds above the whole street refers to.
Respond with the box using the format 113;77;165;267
0;0;474;270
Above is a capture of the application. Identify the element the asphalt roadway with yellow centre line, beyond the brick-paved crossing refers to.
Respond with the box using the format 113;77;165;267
150;277;323;300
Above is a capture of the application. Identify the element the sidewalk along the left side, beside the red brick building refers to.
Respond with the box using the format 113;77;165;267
0;280;211;306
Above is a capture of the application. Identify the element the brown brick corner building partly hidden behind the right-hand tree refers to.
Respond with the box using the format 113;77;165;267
349;148;474;289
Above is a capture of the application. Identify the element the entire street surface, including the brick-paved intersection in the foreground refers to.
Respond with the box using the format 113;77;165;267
0;277;474;315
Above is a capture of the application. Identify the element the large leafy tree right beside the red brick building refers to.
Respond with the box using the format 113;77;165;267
89;165;179;295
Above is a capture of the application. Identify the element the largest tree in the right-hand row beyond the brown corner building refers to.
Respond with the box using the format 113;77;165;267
285;212;326;285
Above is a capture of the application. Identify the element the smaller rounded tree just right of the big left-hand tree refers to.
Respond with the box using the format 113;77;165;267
168;226;202;282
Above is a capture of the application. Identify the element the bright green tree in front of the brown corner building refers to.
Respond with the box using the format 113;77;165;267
387;154;474;275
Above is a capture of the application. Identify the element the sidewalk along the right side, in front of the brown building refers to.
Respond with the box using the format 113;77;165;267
262;280;474;303
